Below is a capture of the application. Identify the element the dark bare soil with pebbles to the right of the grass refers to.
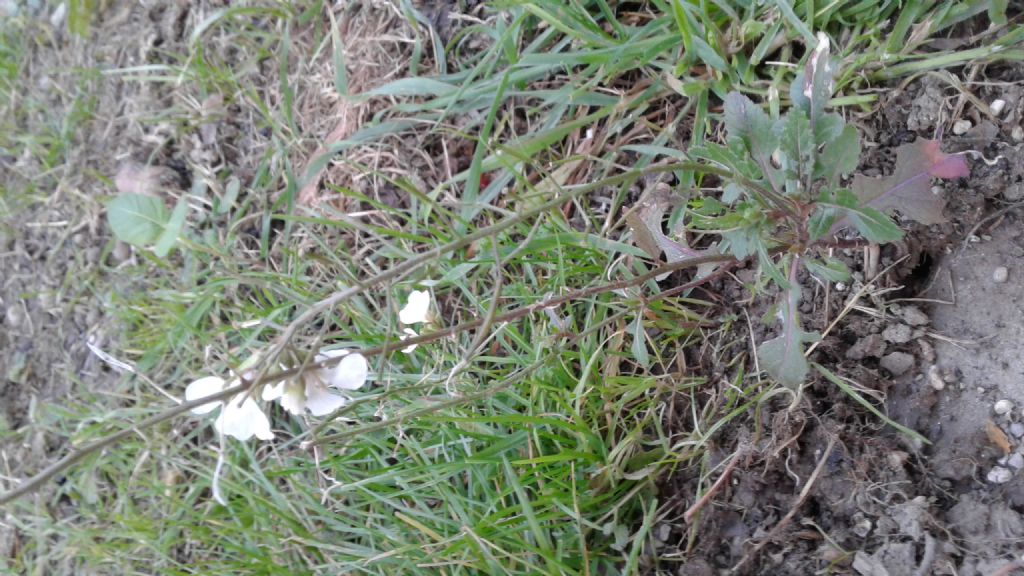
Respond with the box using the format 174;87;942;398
659;67;1024;576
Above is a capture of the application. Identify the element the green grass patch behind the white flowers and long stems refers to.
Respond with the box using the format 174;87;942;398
0;0;1024;575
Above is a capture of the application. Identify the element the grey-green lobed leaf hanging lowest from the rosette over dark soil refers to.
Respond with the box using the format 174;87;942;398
758;282;820;389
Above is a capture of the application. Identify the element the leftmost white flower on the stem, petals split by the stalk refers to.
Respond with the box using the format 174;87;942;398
185;376;273;441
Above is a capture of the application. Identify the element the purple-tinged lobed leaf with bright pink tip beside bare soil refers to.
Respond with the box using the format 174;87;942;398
851;139;971;224
